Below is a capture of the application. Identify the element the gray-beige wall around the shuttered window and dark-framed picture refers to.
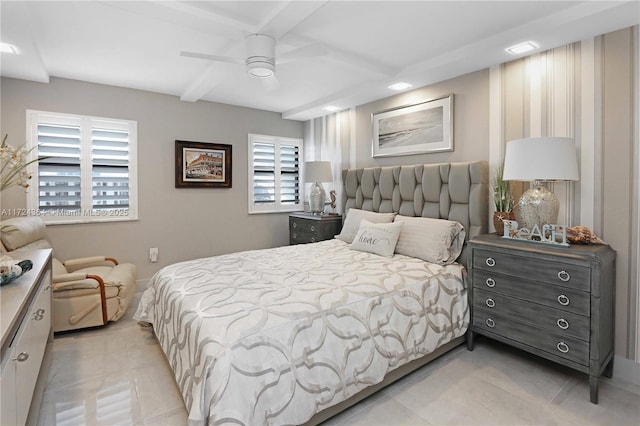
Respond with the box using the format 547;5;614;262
0;78;304;279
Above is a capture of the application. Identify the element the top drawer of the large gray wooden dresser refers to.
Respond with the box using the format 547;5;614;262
473;249;591;291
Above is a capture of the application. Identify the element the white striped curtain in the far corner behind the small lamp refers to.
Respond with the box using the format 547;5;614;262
304;108;356;214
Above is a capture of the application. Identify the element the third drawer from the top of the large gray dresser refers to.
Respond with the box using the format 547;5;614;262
473;288;590;341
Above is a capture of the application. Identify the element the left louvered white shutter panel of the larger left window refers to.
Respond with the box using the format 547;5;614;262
37;123;82;212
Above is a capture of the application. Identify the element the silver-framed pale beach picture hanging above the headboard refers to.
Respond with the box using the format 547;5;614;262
372;95;453;157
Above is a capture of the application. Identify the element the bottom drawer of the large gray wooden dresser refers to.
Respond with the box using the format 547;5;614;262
473;309;589;366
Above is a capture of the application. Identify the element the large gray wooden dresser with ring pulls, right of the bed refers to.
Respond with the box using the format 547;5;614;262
467;234;615;404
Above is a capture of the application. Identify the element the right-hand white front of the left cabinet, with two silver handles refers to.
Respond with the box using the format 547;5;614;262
14;272;51;424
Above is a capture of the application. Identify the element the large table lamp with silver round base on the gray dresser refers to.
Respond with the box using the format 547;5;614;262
503;137;578;230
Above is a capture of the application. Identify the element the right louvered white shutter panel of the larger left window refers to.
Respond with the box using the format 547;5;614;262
91;127;129;209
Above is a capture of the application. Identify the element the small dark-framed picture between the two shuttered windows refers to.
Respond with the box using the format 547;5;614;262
176;140;231;188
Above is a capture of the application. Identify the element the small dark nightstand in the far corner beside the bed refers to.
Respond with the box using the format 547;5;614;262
289;213;342;244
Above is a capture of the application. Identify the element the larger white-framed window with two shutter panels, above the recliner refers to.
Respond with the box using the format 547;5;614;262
27;111;138;223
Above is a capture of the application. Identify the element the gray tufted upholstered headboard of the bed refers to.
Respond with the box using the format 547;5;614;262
342;161;489;263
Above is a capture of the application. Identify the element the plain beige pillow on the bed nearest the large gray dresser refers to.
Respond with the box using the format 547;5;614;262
394;215;465;265
